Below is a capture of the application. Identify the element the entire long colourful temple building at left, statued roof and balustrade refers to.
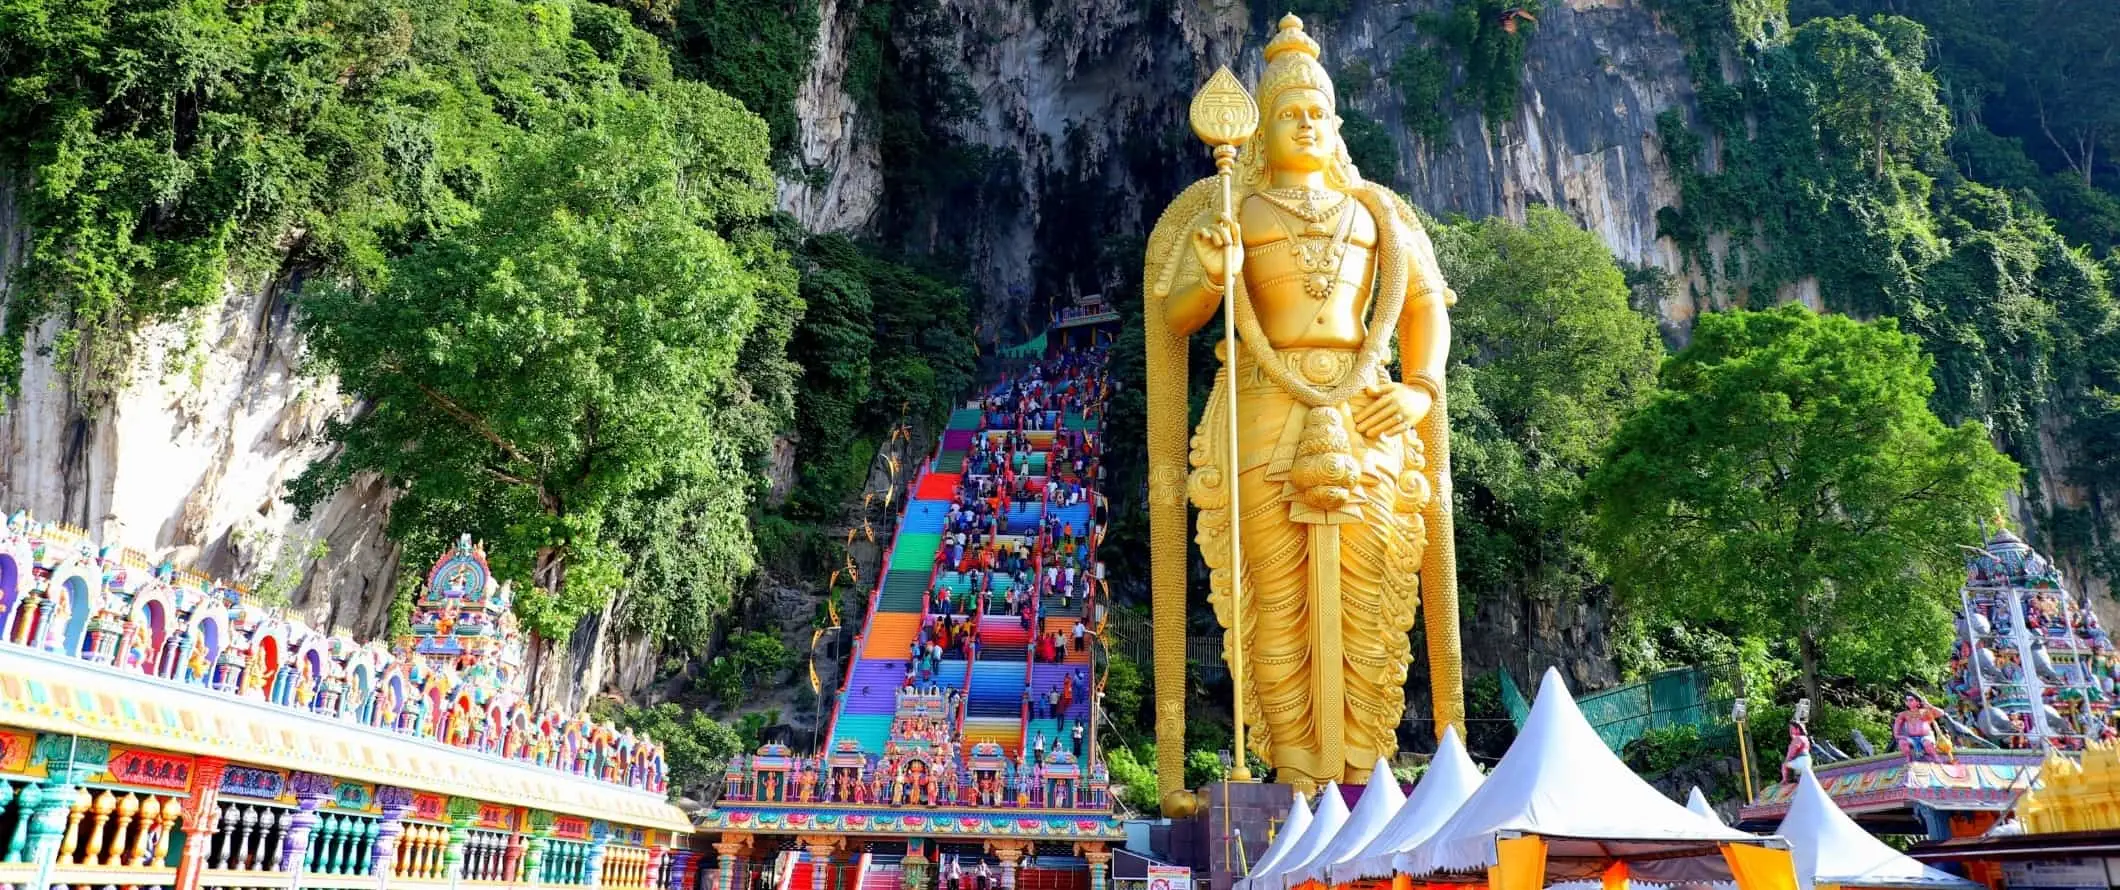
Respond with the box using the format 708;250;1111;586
0;521;693;890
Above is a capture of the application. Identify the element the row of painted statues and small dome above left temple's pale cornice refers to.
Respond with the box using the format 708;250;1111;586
0;513;668;793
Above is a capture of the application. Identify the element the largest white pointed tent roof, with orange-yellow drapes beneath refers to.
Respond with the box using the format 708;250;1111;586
1399;670;1768;884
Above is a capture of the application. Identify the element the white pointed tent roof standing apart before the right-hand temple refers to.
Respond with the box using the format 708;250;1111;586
1777;769;1976;890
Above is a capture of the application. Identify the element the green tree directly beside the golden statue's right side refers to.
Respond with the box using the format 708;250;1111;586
1435;208;1664;627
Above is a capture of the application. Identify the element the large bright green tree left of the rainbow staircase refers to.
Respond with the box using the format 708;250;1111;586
293;83;793;638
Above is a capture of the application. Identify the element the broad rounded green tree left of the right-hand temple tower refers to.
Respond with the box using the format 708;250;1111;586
1588;305;2016;708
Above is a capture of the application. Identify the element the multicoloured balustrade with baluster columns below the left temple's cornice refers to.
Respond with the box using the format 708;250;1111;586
0;729;695;890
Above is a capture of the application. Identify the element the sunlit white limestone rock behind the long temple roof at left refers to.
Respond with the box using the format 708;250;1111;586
0;182;635;706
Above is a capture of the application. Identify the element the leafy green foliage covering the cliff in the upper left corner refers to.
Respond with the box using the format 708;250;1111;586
0;0;670;388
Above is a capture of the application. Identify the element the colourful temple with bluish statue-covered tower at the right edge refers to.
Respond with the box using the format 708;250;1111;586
1741;530;2120;890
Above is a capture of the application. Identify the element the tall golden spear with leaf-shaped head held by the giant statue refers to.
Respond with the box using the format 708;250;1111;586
1191;66;1259;782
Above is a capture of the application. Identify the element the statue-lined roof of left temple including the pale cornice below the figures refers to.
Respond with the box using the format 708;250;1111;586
0;513;689;831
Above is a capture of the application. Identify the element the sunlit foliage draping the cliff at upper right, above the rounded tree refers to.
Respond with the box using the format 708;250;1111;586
1658;0;2120;589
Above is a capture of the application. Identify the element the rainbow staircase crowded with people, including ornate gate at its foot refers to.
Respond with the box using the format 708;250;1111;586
695;311;1126;890
